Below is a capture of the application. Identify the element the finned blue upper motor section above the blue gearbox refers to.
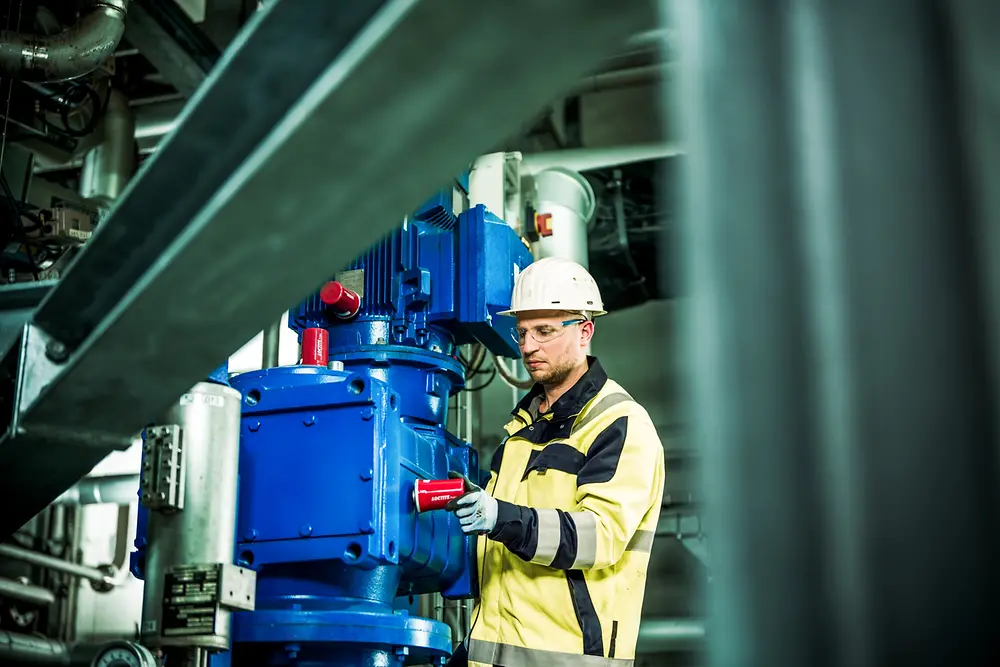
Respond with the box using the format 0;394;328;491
289;205;531;358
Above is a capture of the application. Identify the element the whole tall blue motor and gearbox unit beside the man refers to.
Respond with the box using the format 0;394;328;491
224;196;531;666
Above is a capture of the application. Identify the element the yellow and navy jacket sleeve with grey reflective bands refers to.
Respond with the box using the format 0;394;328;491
489;409;664;570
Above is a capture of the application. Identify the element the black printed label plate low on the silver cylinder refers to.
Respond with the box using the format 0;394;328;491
160;564;220;637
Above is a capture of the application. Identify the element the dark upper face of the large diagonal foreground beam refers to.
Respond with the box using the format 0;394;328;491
35;0;383;348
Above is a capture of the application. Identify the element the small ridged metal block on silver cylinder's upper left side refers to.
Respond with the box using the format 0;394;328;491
139;424;184;512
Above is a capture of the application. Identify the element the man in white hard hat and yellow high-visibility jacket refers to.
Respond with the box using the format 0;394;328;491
449;258;664;667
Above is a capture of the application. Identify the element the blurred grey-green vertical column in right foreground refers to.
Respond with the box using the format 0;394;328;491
669;0;1000;667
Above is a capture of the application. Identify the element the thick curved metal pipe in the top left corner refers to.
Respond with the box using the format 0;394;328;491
0;0;128;81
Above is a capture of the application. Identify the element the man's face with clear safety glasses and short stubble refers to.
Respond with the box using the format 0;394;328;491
517;310;594;385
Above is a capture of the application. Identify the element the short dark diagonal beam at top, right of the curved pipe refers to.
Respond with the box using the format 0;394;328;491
125;0;220;96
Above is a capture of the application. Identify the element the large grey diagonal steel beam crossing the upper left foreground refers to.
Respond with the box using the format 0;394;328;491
0;0;655;534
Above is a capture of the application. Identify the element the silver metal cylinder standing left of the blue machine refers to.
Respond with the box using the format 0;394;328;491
142;382;241;651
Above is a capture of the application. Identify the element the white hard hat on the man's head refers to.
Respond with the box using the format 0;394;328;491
499;257;607;317
